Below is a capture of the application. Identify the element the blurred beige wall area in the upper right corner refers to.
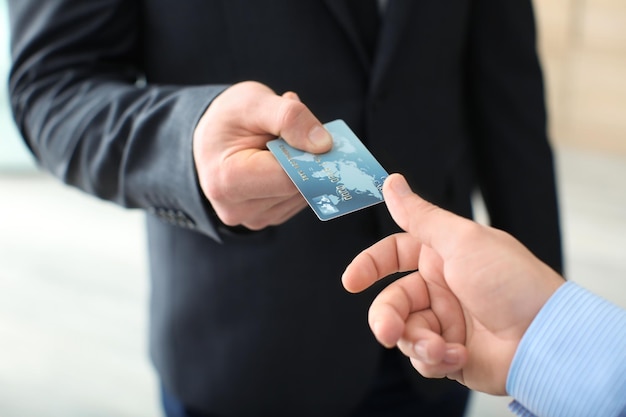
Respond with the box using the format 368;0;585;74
534;0;626;155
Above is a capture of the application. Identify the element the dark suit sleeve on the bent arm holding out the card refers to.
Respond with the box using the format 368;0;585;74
9;0;224;239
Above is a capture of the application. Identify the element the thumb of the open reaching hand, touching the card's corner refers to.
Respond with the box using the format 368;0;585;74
383;174;469;258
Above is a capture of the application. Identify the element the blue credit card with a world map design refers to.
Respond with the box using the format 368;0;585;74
267;120;389;221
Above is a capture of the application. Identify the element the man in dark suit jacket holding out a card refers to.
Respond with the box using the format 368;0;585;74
9;0;561;417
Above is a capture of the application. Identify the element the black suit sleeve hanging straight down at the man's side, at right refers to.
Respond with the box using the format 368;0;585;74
468;0;562;272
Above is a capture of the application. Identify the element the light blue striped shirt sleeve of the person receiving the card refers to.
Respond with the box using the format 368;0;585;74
507;281;626;417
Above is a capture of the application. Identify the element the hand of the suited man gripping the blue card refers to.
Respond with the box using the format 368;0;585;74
193;82;332;230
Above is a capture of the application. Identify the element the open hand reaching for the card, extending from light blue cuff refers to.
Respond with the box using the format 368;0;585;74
342;174;564;395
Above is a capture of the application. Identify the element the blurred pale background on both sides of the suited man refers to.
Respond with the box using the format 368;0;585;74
0;0;626;417
